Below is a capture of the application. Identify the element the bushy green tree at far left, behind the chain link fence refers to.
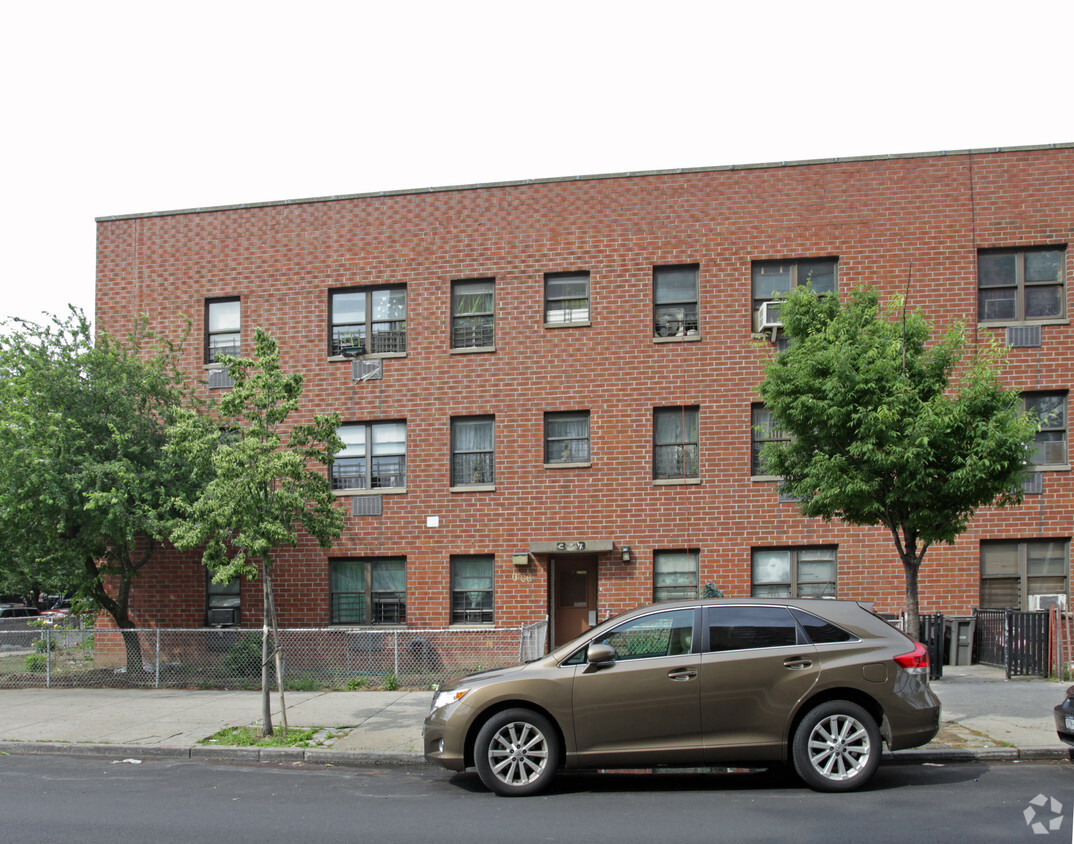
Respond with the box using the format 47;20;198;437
0;308;191;674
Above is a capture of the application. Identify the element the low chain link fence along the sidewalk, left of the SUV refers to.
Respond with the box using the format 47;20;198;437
0;621;548;690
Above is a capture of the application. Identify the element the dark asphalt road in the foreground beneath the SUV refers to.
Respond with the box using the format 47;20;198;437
6;756;1074;844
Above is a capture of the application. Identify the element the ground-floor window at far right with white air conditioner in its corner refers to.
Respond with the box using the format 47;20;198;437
981;539;1070;610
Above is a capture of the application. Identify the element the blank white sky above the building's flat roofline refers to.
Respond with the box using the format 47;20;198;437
0;0;1074;319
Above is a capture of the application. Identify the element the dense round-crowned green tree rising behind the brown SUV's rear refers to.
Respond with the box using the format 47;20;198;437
760;287;1039;639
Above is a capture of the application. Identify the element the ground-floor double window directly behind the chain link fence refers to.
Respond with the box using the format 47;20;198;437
329;557;406;624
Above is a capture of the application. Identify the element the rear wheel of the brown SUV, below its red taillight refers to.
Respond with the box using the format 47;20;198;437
790;700;881;791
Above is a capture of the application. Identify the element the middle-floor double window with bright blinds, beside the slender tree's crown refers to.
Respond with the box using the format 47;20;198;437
332;422;406;491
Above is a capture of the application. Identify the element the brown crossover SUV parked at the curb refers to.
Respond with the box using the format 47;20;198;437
424;598;940;796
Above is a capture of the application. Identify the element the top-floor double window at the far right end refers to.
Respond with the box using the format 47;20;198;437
977;249;1066;322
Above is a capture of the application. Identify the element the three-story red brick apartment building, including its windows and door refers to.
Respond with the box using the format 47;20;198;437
97;145;1074;640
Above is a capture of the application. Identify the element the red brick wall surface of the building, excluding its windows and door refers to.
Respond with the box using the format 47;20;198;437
97;147;1074;626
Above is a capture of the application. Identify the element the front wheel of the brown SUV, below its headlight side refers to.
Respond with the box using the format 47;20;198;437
474;709;560;797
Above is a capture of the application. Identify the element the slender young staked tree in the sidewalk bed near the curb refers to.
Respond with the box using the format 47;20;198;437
169;329;344;736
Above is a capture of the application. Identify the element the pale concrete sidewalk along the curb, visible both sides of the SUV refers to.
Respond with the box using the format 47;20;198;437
0;666;1068;765
